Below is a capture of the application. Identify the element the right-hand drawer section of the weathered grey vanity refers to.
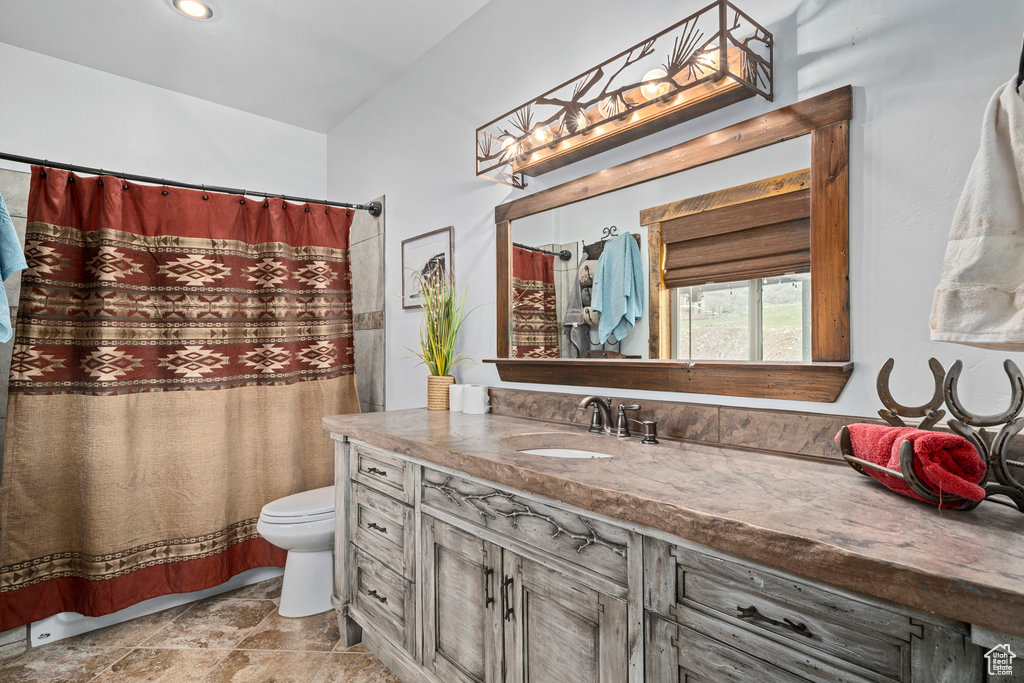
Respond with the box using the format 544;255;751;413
644;538;981;683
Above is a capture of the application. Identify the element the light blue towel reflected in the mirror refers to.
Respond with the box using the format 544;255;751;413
590;232;644;344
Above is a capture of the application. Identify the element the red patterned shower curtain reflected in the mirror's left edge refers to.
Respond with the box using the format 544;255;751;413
512;247;560;358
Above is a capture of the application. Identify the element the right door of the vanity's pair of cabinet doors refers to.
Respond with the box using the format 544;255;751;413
502;550;629;683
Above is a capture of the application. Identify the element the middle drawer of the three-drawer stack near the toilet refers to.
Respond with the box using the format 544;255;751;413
349;482;414;579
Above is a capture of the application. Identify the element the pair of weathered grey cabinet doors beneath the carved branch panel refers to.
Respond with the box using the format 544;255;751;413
423;516;628;683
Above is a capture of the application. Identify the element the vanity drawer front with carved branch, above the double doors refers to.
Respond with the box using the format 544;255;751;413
422;469;629;585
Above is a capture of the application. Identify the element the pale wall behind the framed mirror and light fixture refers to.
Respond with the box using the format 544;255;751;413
328;0;1024;416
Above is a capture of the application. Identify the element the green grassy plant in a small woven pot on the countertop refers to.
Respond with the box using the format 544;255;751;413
410;268;469;411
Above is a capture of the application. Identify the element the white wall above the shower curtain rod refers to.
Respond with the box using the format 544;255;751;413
0;43;327;198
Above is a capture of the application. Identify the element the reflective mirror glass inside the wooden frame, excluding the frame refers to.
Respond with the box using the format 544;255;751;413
507;136;811;361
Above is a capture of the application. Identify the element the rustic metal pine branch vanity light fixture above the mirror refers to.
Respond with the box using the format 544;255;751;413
476;0;774;187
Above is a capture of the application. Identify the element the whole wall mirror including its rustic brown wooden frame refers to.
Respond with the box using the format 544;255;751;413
486;86;853;401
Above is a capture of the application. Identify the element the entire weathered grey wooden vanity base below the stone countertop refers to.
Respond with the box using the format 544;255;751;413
335;435;983;683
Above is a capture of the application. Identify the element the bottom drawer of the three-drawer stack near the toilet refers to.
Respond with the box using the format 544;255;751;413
350;546;416;651
